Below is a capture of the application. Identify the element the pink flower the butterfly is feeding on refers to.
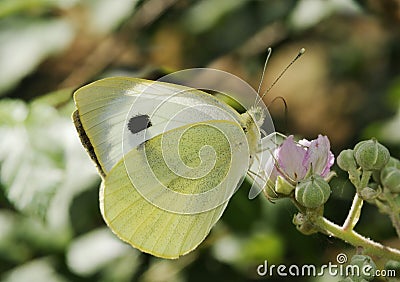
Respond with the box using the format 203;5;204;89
270;135;335;185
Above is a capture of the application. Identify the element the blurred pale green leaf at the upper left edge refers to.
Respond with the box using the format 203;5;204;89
0;19;74;94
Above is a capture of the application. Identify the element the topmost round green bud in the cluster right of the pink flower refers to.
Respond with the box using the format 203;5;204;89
354;139;390;170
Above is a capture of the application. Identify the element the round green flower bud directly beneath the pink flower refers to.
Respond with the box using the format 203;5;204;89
295;175;331;209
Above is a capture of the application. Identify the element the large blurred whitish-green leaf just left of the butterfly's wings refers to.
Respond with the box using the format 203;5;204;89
0;100;95;225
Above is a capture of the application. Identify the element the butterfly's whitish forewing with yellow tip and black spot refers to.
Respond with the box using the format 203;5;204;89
74;77;244;174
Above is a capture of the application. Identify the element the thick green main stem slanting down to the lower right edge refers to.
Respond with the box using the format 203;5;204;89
313;216;400;261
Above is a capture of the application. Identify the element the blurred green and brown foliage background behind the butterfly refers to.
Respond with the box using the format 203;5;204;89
0;0;400;282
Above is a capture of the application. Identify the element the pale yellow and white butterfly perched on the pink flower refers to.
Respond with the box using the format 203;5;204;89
73;66;284;259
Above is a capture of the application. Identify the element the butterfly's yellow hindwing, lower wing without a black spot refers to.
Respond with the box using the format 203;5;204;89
100;121;248;258
